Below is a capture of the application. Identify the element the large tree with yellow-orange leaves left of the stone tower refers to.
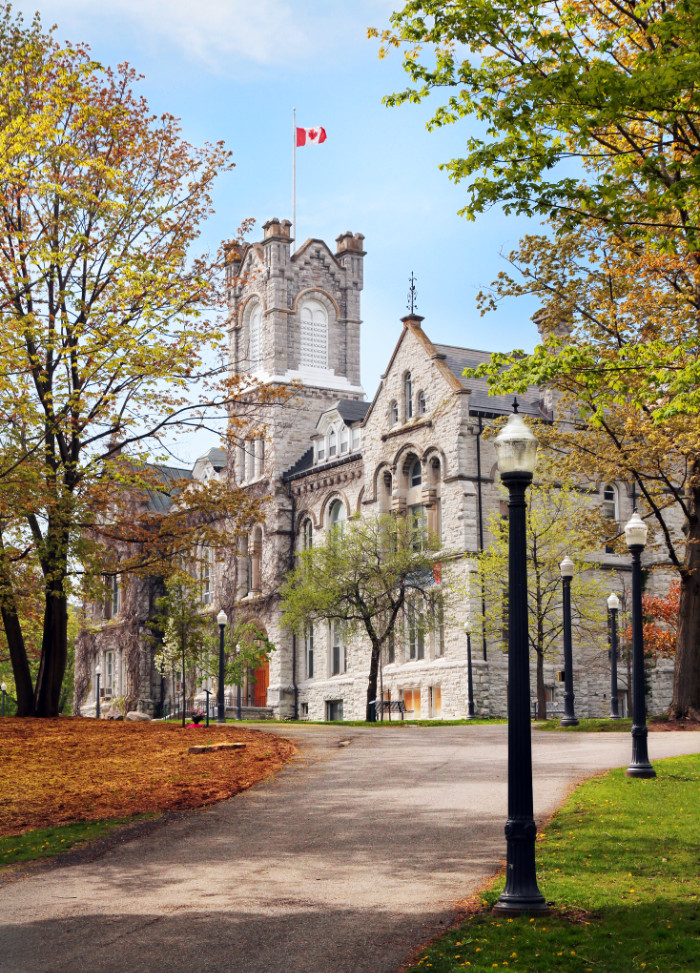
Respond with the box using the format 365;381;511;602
0;6;262;716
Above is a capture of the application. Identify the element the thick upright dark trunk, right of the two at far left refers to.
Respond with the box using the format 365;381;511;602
34;565;68;717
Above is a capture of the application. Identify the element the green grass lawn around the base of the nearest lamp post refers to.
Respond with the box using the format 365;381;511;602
406;755;700;973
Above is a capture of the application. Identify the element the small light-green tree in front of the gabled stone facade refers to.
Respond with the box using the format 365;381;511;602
281;516;444;720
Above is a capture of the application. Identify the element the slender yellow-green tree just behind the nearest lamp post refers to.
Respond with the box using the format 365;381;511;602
476;457;608;719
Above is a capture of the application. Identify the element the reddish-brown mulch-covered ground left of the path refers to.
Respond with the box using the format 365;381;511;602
0;717;295;835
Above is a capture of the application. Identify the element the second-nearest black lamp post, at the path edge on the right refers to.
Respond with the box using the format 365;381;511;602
625;510;656;777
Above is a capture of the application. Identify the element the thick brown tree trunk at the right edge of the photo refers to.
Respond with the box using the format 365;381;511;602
669;474;700;720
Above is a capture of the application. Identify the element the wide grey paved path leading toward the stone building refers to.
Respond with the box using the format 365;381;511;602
0;726;700;973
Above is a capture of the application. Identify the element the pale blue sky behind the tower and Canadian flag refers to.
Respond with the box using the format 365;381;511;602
13;0;538;458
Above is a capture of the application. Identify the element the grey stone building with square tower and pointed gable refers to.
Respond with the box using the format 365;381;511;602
78;220;672;720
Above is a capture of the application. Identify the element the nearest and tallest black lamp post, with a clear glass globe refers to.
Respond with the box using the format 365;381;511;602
494;399;549;915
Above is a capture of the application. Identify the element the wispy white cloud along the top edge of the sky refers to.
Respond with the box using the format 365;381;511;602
21;0;400;74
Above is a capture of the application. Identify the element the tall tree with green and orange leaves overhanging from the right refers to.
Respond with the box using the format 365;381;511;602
375;0;700;716
